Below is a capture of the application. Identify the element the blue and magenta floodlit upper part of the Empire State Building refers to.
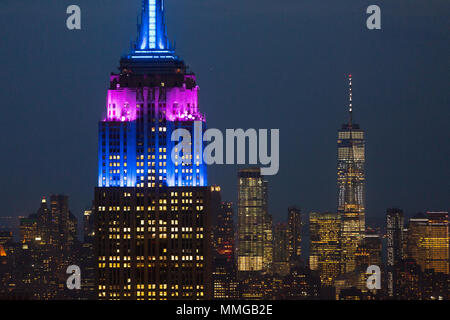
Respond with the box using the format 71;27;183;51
98;0;207;188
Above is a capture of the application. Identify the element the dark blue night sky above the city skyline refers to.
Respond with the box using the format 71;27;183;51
0;0;450;226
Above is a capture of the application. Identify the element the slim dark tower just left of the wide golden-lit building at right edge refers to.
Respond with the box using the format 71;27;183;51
386;208;404;297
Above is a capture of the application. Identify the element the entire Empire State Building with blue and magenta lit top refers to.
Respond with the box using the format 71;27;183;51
94;0;215;300
